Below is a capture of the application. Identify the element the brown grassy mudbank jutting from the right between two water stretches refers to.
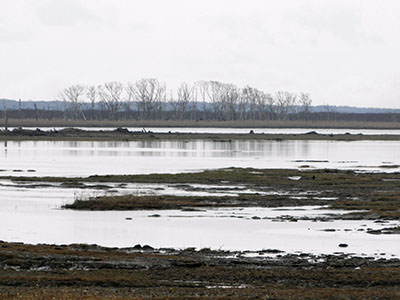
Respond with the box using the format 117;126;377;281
4;169;400;220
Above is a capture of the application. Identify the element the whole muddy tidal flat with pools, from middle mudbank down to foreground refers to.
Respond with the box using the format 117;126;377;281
0;169;400;299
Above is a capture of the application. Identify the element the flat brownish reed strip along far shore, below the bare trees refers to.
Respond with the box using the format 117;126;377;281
0;119;400;129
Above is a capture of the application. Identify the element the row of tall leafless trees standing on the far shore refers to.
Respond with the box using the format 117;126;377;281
59;78;312;121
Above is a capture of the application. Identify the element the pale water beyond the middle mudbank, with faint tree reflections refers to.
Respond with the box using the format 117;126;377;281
0;140;400;176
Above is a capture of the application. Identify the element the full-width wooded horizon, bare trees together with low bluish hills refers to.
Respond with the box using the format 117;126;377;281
0;79;400;122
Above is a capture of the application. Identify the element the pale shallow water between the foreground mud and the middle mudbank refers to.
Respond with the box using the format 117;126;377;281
0;186;400;257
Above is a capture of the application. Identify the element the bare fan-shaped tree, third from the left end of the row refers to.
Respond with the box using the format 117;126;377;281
98;81;123;119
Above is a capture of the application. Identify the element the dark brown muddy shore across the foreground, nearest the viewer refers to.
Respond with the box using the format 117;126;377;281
0;242;400;300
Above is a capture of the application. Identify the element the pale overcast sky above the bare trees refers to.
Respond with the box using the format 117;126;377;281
0;0;400;108
